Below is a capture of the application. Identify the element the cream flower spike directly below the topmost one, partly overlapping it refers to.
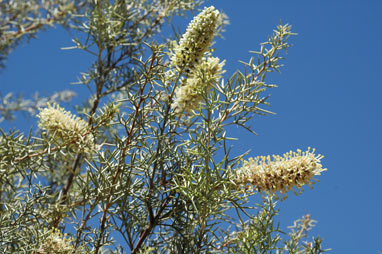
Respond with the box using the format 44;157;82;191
172;57;224;114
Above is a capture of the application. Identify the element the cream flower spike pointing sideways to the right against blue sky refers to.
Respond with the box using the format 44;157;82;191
234;148;326;199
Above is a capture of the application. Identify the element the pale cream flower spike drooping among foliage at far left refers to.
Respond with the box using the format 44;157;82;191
37;104;98;154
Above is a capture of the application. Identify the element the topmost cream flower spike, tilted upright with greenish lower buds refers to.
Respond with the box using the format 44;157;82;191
171;6;221;71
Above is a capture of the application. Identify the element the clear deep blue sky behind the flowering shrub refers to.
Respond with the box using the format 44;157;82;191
0;0;382;253
